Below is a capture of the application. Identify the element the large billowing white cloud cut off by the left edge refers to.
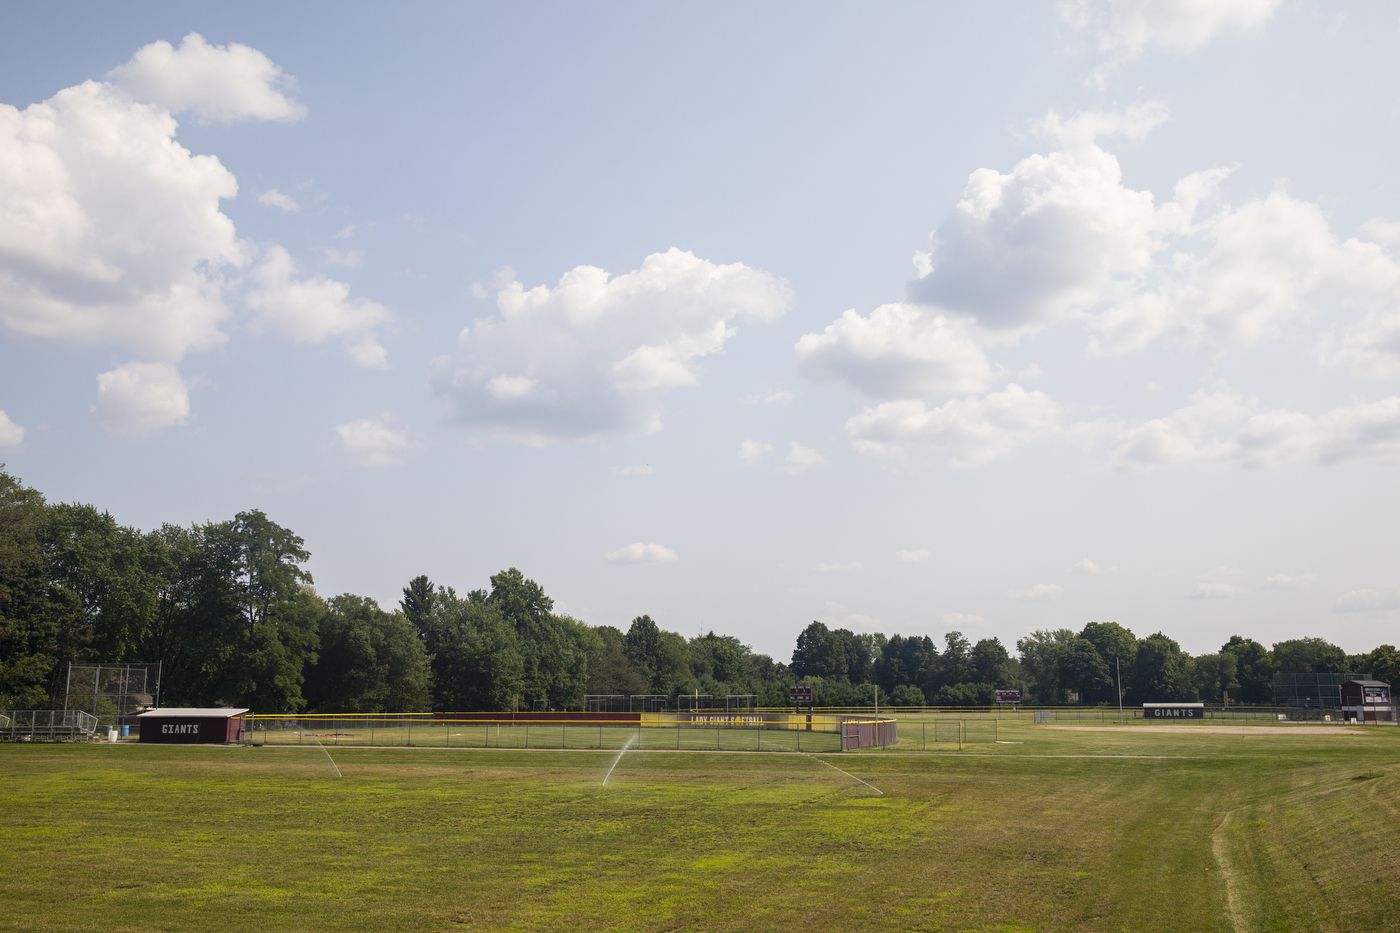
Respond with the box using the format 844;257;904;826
0;81;249;361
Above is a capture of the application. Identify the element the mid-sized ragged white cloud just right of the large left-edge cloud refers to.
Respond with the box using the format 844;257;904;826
246;247;389;367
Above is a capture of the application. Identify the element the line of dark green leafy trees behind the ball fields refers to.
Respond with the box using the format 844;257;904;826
0;468;1400;712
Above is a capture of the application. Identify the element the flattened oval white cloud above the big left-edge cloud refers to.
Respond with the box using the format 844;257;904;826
108;32;307;123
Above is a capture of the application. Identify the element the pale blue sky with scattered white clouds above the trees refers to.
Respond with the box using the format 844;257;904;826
0;0;1400;657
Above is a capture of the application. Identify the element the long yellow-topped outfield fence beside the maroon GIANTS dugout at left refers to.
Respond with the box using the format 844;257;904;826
242;712;899;752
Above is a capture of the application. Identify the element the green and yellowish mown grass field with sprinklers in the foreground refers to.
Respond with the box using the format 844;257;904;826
0;714;1400;930
